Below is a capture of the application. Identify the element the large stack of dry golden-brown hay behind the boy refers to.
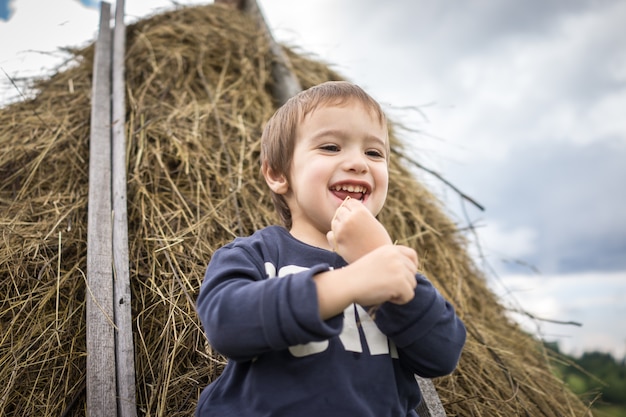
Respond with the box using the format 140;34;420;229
0;5;591;417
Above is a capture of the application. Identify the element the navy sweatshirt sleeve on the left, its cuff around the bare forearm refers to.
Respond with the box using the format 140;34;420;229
197;246;343;360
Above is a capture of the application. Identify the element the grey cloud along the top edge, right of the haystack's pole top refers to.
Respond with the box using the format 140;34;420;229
338;0;604;52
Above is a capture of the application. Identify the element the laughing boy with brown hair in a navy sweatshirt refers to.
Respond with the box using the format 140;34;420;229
196;82;465;417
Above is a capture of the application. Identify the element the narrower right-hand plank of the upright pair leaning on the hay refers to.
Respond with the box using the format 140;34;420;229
111;0;137;417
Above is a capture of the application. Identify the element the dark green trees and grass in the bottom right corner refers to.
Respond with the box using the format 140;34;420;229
545;343;626;417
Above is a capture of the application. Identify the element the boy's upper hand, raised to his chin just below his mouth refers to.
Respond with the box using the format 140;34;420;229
326;197;393;263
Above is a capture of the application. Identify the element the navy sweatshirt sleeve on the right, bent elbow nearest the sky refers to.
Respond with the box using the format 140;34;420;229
375;274;466;378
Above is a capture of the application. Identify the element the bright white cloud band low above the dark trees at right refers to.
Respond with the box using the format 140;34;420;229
491;271;626;358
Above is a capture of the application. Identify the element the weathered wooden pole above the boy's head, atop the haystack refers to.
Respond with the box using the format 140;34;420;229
216;0;302;106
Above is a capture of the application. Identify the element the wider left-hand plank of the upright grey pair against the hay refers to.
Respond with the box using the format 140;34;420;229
85;2;117;417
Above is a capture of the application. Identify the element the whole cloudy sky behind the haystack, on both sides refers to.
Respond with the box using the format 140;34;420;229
0;0;626;359
